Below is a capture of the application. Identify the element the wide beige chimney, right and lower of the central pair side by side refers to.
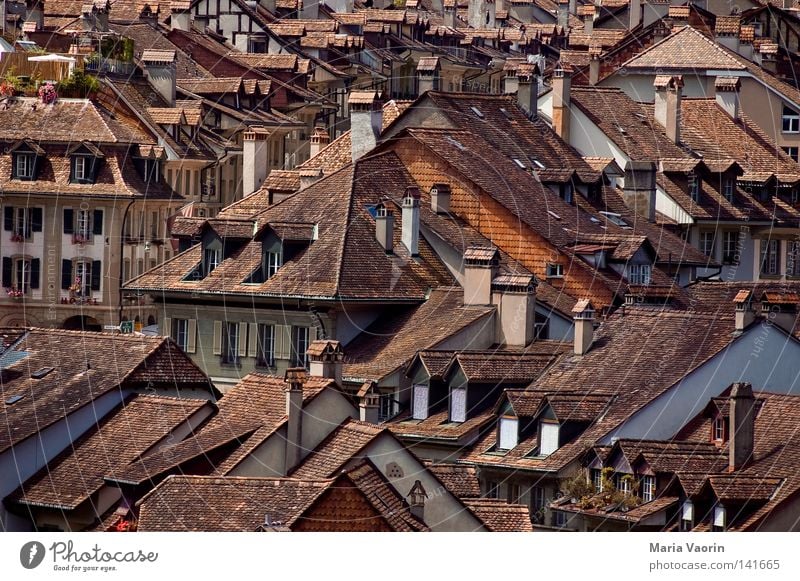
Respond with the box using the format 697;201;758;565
492;274;536;347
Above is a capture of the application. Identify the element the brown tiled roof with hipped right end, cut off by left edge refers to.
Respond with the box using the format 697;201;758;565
0;329;211;451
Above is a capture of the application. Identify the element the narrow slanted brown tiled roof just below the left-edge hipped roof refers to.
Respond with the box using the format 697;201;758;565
11;395;209;510
